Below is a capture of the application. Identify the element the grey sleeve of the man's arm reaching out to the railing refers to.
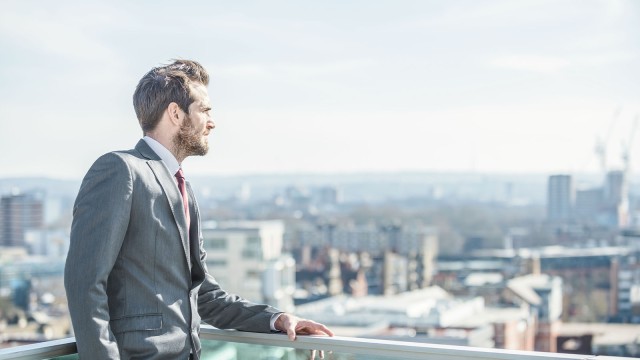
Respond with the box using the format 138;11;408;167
198;236;281;333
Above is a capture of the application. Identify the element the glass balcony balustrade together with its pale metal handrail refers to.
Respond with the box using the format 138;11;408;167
0;325;630;360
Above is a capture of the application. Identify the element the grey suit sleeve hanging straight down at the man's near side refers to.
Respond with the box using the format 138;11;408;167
64;153;133;359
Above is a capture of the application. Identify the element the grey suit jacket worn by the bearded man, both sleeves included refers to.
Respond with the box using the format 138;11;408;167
65;140;278;360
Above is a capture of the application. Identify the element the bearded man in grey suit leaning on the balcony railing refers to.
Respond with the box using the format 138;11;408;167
65;60;333;360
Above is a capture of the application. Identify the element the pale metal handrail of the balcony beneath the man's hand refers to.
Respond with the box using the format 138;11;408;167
0;326;631;360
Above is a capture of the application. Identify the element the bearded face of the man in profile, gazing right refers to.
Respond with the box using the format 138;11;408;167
173;84;215;157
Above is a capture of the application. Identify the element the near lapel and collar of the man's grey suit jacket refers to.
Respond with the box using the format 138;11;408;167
136;140;191;269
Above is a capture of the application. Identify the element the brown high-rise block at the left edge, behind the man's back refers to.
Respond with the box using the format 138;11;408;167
0;193;44;246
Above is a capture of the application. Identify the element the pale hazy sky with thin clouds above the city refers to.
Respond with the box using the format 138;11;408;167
0;0;640;179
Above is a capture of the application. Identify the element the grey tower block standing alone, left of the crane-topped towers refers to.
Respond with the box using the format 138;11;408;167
547;175;575;222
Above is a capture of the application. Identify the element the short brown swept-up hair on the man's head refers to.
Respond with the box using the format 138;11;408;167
133;60;209;133
